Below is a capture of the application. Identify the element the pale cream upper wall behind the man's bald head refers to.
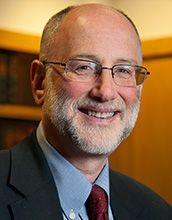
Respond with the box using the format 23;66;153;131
0;0;172;40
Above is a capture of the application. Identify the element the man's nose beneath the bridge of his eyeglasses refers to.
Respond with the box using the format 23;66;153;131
90;68;118;102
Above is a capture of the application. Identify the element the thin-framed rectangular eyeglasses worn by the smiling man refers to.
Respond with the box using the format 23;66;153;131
42;59;150;87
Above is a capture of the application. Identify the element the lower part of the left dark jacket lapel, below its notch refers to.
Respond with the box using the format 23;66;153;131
10;180;62;220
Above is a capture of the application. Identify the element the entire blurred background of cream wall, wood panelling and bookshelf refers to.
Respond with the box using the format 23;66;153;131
0;0;172;204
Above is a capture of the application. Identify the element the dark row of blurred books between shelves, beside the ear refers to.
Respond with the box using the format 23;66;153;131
0;49;37;105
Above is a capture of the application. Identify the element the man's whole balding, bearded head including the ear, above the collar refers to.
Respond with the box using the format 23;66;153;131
32;4;146;155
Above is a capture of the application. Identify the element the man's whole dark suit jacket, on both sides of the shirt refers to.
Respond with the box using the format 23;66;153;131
0;131;172;220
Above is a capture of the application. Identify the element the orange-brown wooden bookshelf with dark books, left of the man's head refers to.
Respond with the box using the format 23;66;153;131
0;30;41;149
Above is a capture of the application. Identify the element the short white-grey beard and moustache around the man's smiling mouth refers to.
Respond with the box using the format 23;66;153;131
43;74;140;155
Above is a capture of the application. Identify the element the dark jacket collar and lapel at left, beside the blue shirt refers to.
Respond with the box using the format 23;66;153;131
9;132;62;220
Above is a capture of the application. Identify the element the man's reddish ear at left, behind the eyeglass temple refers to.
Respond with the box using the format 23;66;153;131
30;60;45;105
